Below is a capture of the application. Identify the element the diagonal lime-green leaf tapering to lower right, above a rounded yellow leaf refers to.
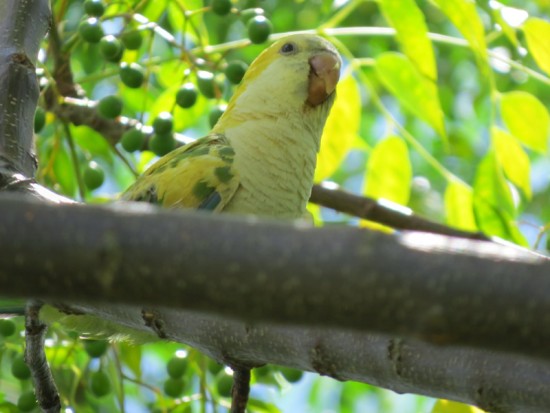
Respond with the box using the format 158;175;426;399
375;52;446;138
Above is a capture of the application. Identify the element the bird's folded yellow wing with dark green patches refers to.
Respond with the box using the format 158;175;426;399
121;134;240;211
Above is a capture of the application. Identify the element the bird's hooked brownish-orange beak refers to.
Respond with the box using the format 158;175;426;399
307;52;340;106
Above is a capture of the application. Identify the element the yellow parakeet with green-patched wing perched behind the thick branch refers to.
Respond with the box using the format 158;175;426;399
121;34;341;218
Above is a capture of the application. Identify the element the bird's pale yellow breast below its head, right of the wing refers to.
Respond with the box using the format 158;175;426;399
224;110;324;218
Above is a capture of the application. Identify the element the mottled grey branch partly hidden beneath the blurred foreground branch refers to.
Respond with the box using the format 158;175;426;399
73;304;550;413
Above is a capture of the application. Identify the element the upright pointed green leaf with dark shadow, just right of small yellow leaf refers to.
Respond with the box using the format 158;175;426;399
474;152;527;246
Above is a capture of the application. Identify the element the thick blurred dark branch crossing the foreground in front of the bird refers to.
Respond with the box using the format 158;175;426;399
0;192;550;358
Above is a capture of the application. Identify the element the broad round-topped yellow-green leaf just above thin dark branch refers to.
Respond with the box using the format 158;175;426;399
363;136;412;205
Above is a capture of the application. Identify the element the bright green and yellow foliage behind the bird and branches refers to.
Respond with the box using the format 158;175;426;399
0;0;550;412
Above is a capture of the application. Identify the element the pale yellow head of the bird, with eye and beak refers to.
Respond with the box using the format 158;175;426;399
216;34;341;129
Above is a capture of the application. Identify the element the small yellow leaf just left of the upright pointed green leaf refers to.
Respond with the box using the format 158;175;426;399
445;181;478;232
